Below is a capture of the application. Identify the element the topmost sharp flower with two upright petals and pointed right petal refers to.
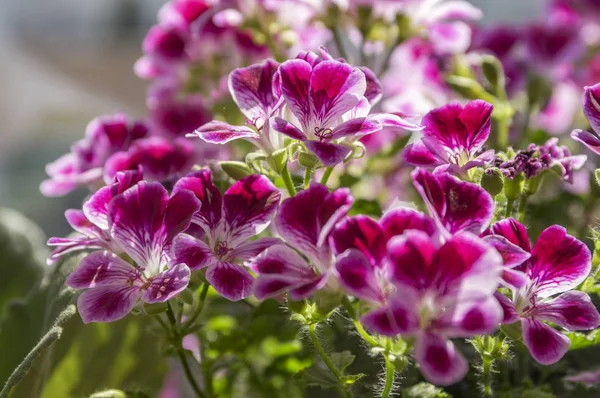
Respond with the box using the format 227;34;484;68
271;51;418;167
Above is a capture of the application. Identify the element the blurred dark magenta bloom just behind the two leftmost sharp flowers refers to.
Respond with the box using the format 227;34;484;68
104;137;196;182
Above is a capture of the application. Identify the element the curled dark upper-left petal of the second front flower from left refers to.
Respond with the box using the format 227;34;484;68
173;169;223;234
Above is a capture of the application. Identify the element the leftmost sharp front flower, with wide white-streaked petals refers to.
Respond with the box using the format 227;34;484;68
66;181;200;323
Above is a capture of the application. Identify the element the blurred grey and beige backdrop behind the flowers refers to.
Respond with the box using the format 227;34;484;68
0;0;544;236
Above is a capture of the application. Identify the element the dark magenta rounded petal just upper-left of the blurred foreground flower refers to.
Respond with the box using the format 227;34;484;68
331;215;386;267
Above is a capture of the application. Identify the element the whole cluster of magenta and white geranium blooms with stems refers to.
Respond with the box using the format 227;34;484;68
41;0;600;396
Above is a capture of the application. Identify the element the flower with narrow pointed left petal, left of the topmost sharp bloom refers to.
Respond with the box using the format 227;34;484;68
188;59;283;153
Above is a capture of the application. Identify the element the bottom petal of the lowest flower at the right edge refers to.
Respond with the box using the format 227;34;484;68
521;318;571;365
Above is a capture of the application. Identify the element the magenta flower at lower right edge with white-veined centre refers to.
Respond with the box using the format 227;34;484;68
494;224;600;365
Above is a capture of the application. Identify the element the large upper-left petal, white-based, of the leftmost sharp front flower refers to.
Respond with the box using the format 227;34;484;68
108;181;169;274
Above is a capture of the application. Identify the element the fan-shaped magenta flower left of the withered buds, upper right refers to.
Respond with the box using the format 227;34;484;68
403;100;494;174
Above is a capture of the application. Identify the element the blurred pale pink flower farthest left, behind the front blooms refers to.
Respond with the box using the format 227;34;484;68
40;113;148;196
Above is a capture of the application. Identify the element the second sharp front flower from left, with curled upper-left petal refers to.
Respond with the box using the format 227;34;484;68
172;170;281;301
